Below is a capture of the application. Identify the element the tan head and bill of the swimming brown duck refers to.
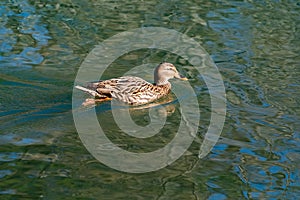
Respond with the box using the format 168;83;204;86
154;62;188;85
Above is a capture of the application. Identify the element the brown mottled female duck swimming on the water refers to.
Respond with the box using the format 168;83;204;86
76;62;187;105
